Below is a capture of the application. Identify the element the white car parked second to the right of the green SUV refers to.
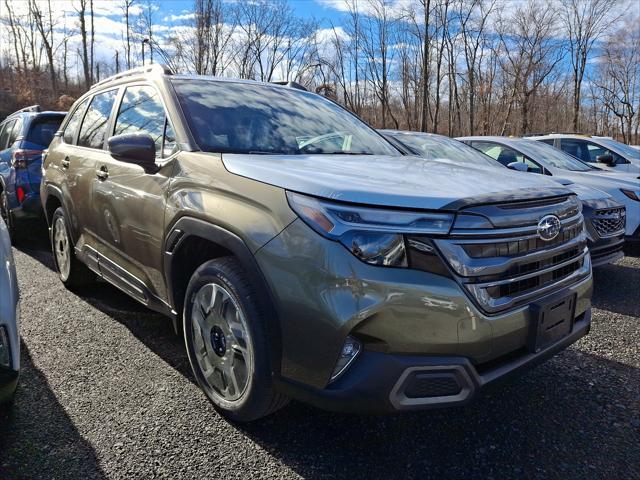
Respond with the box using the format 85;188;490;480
459;137;640;248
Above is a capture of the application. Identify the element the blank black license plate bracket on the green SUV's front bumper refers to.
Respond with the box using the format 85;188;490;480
528;293;576;353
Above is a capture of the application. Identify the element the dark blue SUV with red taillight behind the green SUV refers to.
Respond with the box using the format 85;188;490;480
0;105;66;237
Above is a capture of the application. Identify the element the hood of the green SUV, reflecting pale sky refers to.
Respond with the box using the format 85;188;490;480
222;154;571;209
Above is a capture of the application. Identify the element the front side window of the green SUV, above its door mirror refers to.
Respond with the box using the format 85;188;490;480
114;86;176;157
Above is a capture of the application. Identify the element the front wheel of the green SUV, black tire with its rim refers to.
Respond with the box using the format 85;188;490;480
183;257;288;422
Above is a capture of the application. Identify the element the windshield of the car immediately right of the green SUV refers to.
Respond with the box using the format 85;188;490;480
389;132;502;168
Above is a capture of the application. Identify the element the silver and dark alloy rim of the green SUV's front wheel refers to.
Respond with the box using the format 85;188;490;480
191;283;253;402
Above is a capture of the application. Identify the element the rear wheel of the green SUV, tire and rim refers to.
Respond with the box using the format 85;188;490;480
51;207;95;290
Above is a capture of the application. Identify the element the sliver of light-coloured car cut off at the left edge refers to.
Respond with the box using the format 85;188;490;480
0;214;20;404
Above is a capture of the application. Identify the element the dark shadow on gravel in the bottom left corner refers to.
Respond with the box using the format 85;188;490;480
0;343;106;480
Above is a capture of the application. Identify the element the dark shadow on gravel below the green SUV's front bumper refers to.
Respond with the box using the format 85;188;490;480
238;350;640;479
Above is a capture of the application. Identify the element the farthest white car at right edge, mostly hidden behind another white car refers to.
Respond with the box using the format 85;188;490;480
527;133;640;174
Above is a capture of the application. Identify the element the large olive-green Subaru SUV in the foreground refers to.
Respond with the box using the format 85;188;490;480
41;65;592;421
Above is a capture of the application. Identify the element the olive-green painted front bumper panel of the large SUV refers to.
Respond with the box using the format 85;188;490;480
255;220;592;396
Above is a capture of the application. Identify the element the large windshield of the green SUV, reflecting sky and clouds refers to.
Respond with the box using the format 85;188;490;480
172;78;400;156
